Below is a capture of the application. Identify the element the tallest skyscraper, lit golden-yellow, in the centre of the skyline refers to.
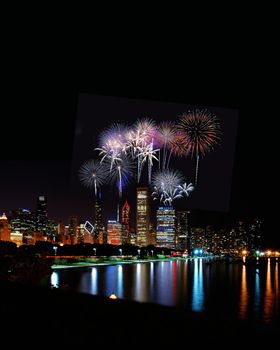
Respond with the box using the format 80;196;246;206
136;187;150;247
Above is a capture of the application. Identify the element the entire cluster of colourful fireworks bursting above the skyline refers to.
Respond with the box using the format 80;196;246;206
79;109;221;205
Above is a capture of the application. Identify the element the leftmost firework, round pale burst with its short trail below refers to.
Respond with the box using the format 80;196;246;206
79;159;106;196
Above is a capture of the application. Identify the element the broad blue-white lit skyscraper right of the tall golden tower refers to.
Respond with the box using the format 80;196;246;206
156;207;175;249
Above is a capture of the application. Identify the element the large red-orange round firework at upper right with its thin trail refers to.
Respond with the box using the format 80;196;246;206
177;109;221;185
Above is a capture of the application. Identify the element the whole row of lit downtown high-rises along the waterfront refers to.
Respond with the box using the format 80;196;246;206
0;187;262;254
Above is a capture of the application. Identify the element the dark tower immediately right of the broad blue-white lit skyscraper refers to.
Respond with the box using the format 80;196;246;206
176;210;190;250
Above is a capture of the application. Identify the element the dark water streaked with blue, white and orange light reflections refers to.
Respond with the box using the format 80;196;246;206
51;258;280;324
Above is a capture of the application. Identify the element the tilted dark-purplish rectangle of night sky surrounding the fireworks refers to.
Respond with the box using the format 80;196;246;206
71;94;238;221
